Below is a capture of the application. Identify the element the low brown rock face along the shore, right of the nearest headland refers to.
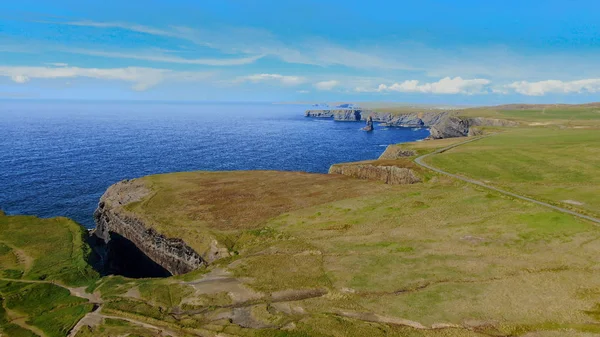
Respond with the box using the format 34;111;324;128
329;162;421;185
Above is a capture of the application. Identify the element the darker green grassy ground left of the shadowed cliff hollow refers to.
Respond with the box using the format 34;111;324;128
0;214;98;337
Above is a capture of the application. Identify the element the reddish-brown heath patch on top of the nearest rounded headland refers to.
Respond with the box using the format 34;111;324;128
124;171;389;253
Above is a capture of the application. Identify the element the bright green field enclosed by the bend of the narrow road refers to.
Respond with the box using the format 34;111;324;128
427;128;600;215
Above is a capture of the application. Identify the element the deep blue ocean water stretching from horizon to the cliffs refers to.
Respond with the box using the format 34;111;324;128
0;101;429;228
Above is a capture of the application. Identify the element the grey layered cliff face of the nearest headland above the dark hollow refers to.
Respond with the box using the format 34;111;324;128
94;180;206;275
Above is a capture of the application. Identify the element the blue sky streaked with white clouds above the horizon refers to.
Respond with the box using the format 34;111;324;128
0;0;600;104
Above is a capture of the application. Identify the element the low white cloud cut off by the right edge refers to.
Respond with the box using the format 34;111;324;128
505;78;600;96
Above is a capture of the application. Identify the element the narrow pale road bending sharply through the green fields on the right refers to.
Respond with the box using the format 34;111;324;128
415;135;600;224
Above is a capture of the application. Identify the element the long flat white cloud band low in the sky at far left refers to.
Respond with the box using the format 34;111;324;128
0;66;212;91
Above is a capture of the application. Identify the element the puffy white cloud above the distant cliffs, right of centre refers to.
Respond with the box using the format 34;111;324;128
380;77;491;95
